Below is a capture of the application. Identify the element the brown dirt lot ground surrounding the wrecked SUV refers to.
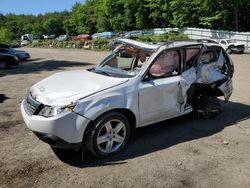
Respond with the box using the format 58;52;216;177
0;48;250;188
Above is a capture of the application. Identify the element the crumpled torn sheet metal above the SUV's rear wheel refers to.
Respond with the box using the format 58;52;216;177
196;51;227;84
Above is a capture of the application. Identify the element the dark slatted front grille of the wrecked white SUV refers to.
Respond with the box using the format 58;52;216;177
25;93;43;115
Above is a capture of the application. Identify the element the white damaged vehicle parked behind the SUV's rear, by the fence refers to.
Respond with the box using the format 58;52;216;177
218;39;245;54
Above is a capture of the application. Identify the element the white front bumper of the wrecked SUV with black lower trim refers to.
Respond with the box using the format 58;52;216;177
21;100;90;149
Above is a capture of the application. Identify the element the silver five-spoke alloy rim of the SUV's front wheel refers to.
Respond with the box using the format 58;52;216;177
97;120;126;153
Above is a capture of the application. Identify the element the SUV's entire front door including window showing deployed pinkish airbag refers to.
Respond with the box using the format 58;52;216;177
139;50;182;126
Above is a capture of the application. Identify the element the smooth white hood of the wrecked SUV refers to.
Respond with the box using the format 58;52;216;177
30;70;128;106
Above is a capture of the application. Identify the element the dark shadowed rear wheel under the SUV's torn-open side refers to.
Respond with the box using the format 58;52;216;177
193;96;222;118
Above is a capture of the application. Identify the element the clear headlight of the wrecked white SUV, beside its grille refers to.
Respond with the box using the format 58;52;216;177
38;103;76;117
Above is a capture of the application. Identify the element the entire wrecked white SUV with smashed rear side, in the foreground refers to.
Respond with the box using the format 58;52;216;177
21;39;234;157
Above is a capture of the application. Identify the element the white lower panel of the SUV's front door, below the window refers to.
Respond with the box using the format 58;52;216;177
139;76;181;125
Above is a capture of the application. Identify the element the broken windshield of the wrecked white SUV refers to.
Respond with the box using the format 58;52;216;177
92;45;151;78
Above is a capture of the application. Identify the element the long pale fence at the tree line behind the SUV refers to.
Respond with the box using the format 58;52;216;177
146;27;250;49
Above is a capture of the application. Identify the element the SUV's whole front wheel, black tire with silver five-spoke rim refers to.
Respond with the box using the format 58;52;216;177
87;111;130;158
